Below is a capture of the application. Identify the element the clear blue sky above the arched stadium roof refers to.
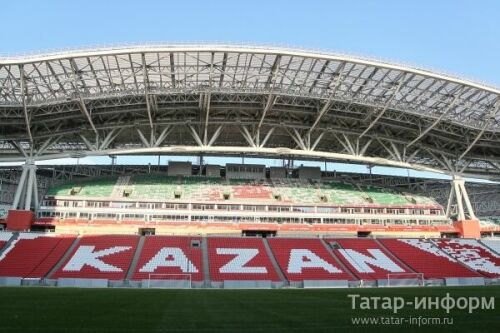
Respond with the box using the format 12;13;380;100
0;0;500;182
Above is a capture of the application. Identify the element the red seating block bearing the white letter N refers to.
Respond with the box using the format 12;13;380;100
327;238;413;280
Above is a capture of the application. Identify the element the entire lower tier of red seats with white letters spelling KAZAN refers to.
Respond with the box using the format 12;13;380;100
0;232;500;282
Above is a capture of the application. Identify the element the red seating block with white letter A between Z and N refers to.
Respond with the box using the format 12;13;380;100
269;238;353;281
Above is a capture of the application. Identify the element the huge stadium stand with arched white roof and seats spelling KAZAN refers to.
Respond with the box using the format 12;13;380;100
0;44;500;331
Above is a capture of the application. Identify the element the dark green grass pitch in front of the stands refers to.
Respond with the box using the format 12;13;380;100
0;286;500;333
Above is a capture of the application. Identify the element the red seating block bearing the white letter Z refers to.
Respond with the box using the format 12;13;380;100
208;237;279;281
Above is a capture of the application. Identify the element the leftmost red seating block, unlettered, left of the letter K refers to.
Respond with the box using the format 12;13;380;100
0;233;75;278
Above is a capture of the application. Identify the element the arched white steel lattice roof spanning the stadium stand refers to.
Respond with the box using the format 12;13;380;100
0;44;500;179
